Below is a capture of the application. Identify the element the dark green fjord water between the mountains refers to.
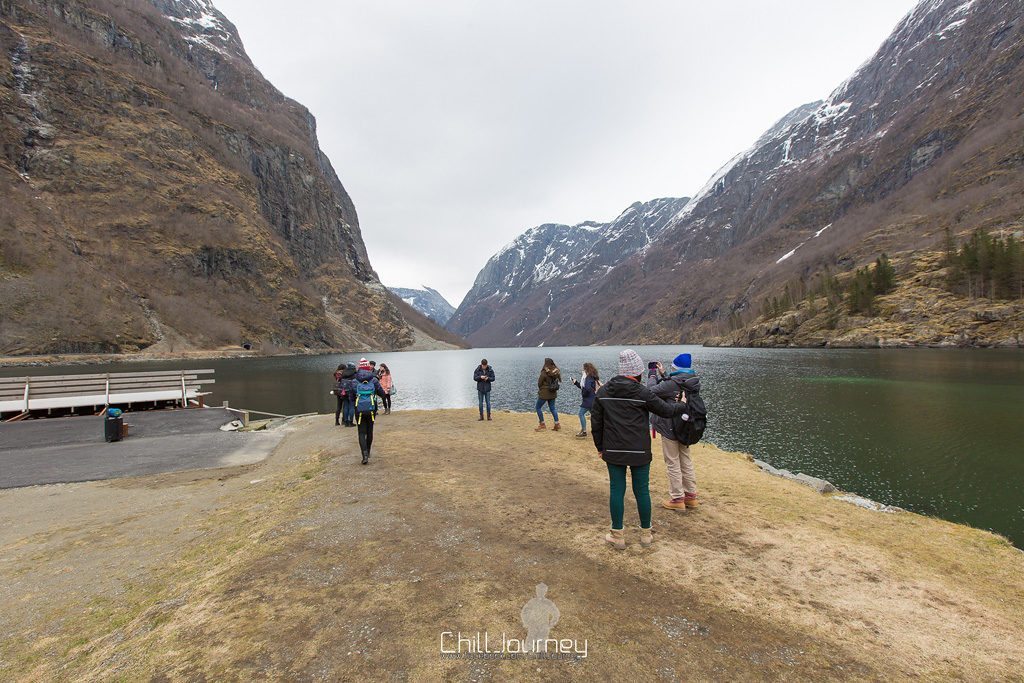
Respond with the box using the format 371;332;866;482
2;346;1024;547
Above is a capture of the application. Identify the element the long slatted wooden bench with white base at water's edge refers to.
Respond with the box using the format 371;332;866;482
0;370;214;420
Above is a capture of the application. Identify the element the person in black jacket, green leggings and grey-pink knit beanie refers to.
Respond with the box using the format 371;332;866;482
591;348;686;550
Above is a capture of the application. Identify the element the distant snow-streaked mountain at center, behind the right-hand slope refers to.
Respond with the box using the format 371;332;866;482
447;198;688;346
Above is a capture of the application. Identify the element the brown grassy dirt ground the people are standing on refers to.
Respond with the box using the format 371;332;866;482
0;411;1024;681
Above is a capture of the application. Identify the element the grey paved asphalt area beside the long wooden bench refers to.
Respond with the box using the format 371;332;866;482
0;409;284;488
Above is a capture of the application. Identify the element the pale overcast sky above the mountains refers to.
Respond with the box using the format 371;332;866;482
214;0;914;306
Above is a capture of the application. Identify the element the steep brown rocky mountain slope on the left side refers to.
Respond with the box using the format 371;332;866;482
0;0;440;354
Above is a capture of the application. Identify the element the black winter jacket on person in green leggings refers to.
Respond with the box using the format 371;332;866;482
590;375;686;467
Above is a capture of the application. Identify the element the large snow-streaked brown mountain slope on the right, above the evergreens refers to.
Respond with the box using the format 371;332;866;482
457;0;1024;344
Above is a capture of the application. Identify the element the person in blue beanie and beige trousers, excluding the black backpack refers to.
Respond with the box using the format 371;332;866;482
647;353;700;510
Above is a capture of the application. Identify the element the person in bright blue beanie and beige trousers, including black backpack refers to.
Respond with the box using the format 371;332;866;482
647;353;708;510
